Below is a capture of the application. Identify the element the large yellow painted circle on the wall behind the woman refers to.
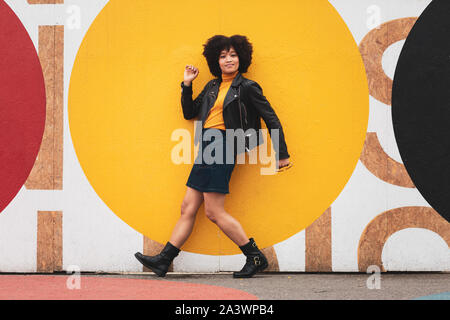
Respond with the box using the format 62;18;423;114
69;0;369;254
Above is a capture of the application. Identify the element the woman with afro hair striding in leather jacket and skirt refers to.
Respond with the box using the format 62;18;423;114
135;35;290;278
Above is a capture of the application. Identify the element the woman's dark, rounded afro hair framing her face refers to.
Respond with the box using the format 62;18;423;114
203;34;253;78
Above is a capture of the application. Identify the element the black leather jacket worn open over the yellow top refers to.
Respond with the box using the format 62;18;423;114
181;72;289;159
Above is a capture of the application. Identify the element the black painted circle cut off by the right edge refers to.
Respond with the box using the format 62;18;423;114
392;0;450;221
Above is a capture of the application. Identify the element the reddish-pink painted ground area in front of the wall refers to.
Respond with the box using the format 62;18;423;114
0;275;258;300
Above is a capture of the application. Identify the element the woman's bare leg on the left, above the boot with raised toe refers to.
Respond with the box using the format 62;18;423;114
169;187;203;249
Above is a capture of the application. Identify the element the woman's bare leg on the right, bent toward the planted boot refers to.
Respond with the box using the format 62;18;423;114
203;192;249;246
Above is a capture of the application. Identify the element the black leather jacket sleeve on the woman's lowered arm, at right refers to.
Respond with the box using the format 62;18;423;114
247;81;290;160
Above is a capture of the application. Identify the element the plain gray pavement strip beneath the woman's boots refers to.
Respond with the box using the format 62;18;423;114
82;272;450;300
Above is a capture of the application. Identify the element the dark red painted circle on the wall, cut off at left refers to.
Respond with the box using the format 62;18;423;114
0;1;45;212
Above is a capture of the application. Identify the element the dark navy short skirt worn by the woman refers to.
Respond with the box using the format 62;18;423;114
186;128;236;194
